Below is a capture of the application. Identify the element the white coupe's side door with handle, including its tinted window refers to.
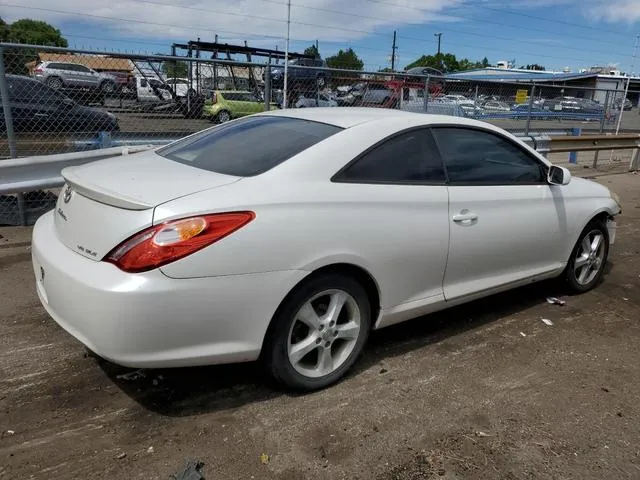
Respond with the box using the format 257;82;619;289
432;126;567;300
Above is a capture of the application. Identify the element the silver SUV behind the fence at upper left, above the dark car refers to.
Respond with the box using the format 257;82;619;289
33;61;116;93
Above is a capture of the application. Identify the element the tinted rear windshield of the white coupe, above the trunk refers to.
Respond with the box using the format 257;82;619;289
156;116;342;177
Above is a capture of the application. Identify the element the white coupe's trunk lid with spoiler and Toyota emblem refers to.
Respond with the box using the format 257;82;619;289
54;151;240;261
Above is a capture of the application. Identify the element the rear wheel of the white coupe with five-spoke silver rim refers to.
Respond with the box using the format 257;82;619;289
263;273;371;392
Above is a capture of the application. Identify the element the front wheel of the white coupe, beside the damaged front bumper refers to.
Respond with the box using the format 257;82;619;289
564;220;609;293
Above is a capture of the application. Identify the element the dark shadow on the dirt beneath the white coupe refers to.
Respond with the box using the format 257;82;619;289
97;272;600;417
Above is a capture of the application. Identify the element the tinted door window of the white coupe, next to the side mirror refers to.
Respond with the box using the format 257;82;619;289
432;127;544;184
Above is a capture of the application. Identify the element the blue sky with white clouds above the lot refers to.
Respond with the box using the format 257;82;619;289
0;0;640;72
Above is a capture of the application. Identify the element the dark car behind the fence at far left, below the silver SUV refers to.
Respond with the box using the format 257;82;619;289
0;75;119;133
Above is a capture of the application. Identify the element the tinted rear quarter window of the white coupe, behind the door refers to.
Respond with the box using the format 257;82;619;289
337;129;445;183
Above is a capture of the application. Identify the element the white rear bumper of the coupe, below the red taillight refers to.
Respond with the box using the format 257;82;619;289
32;213;307;368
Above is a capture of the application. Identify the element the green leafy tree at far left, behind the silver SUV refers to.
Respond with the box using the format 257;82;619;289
0;18;68;75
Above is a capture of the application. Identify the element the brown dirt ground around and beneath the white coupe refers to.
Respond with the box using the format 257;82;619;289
0;173;640;480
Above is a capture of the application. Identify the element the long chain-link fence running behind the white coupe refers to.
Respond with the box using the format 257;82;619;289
0;44;640;225
